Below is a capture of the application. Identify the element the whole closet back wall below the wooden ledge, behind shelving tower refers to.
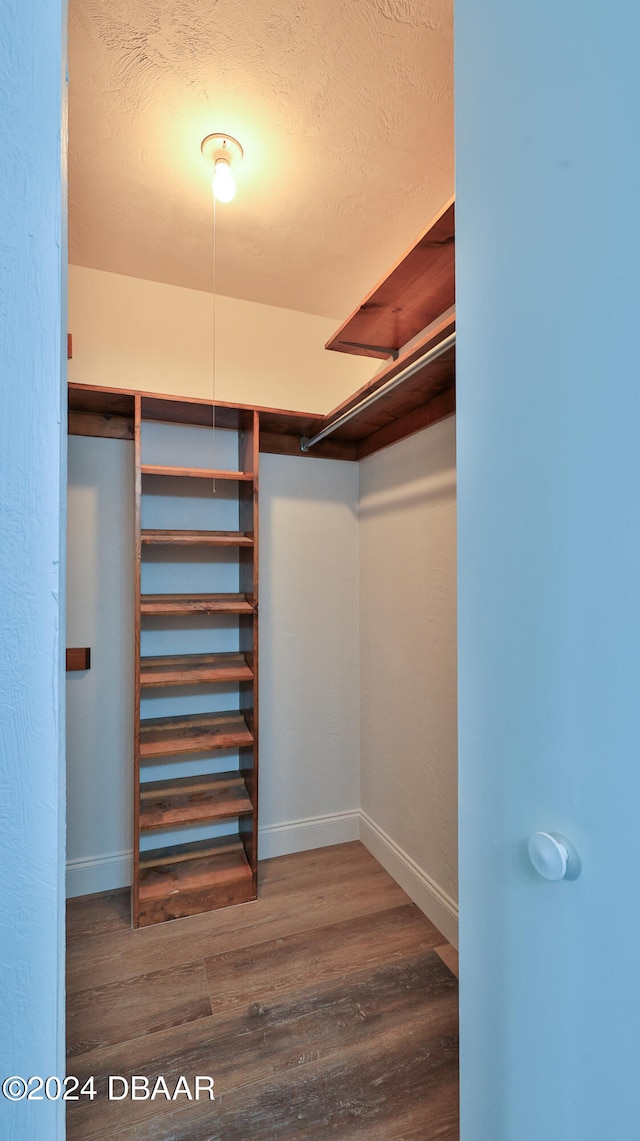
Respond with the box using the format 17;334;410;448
67;435;359;895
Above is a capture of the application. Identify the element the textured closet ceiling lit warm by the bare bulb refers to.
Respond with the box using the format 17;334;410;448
70;0;453;318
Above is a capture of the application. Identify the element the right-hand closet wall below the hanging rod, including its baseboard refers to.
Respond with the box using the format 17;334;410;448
359;416;457;942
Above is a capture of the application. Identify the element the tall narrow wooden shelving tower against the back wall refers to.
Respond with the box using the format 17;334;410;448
131;395;259;926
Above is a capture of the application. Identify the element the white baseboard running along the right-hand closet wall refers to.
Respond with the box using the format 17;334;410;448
360;812;457;947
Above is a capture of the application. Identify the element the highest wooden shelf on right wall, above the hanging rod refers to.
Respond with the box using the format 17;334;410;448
326;200;455;359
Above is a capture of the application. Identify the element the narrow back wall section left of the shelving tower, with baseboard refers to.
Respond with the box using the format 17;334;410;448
66;436;133;895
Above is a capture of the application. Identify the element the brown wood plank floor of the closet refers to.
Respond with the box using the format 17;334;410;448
67;842;459;1141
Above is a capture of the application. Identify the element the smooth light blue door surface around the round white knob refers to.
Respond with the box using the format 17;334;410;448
455;0;640;1141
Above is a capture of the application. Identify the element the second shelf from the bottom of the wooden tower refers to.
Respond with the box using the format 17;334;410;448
140;772;253;831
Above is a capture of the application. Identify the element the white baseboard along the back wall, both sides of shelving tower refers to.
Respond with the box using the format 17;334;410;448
66;811;359;899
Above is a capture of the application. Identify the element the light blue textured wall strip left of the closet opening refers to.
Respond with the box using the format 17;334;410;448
0;0;66;1141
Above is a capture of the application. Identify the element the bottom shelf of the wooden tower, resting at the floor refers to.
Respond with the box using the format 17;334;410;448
139;835;256;926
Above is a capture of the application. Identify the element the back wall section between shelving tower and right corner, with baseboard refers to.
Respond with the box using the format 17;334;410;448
260;455;359;858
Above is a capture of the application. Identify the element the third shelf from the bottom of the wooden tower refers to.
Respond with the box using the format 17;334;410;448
139;710;253;760
